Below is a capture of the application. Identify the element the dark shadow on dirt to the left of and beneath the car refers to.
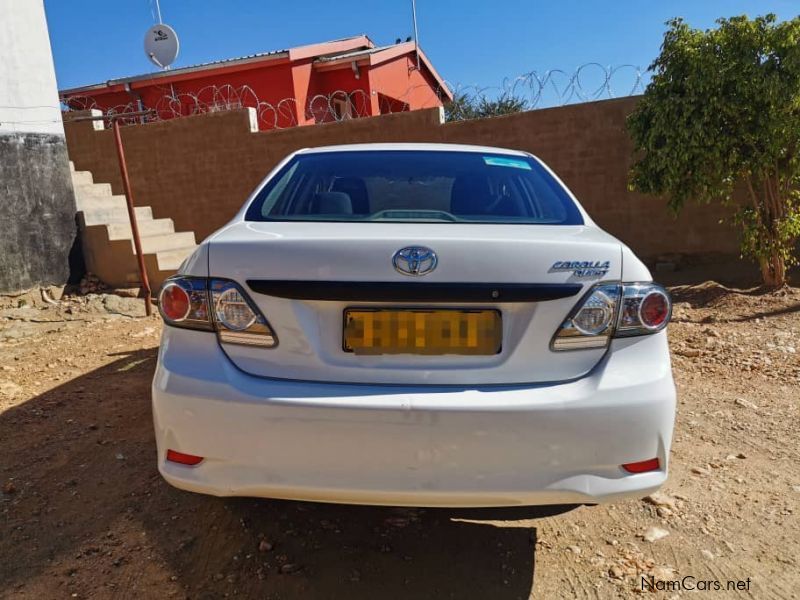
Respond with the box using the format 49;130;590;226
0;349;567;599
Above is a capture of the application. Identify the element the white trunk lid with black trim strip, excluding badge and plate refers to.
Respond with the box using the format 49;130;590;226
209;222;621;385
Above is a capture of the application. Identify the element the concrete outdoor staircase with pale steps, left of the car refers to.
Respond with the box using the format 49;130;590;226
69;161;197;294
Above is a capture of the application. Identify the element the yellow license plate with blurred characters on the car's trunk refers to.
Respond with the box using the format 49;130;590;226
344;309;503;355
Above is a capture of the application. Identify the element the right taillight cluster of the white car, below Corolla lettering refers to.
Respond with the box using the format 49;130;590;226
550;283;672;351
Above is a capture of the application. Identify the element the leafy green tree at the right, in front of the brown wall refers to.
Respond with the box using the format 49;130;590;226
628;14;800;287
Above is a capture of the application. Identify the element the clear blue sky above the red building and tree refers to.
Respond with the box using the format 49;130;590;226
47;0;800;101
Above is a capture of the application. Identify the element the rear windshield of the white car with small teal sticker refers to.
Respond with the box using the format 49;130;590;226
246;150;583;225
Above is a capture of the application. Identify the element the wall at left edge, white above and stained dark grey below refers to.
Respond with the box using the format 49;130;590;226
0;0;76;293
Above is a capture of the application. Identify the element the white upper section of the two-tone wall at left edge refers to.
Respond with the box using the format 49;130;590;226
0;0;64;135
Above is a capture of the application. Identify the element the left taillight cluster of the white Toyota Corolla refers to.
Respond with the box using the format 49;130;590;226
158;276;278;348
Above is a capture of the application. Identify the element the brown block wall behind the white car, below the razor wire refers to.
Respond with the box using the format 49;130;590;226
66;98;737;259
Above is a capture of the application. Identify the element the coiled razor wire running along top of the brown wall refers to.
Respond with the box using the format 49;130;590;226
62;63;644;130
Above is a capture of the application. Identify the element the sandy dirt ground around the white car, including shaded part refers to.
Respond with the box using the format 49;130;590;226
0;284;800;600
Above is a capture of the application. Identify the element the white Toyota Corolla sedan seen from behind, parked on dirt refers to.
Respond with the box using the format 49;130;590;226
153;144;675;507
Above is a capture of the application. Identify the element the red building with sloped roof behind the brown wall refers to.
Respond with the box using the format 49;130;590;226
61;35;452;129
